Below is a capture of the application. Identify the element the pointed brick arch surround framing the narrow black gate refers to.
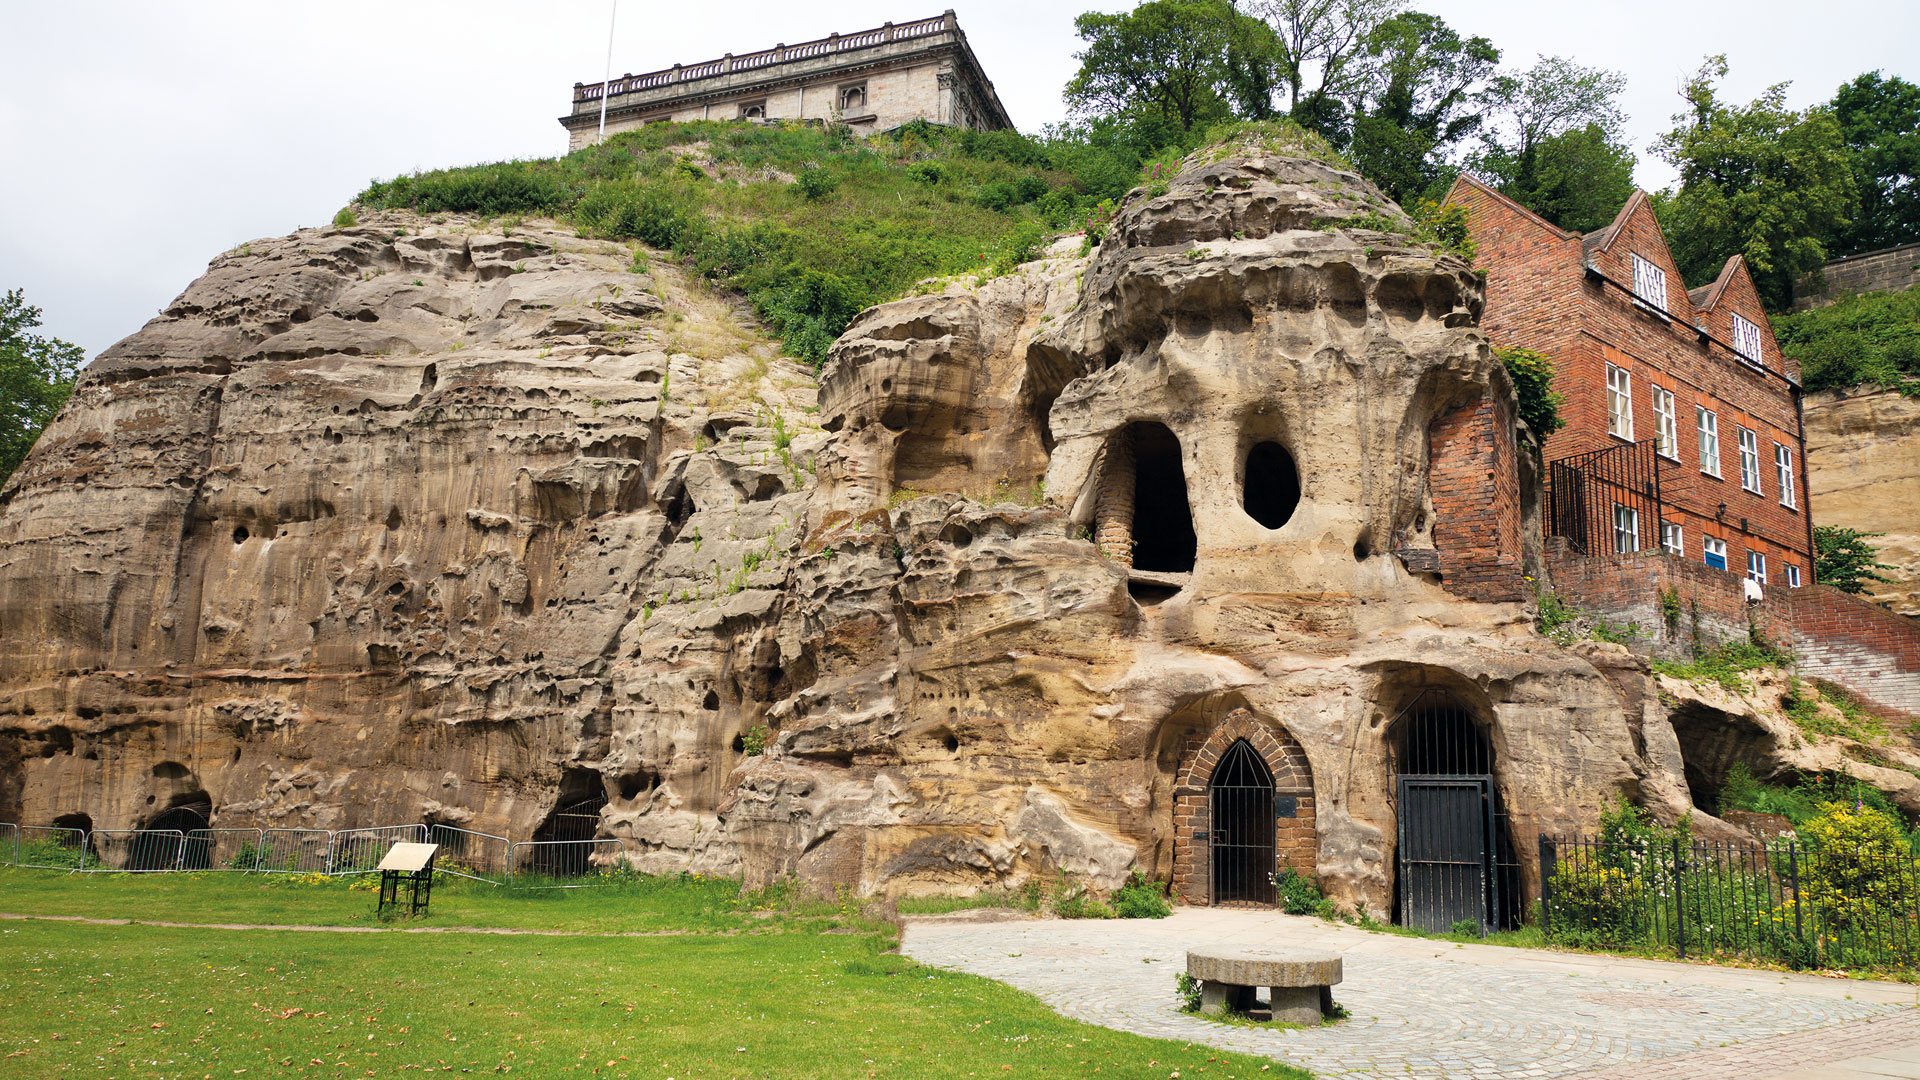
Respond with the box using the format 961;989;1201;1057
1173;709;1319;905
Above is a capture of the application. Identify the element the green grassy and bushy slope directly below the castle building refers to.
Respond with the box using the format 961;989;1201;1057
355;121;1140;363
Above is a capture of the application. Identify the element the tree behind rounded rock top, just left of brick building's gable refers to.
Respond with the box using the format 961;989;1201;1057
1348;12;1500;202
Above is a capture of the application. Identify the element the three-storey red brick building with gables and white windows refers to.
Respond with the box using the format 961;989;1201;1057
1448;177;1812;588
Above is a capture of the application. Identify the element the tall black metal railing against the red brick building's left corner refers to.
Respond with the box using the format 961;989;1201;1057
1548;438;1667;555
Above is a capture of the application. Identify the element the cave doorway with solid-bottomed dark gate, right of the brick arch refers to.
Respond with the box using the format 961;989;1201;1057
1394;688;1524;932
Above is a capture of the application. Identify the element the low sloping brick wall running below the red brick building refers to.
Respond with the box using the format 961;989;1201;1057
1548;544;1920;715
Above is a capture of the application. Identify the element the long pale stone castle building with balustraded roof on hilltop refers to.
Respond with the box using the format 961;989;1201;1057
561;10;1014;150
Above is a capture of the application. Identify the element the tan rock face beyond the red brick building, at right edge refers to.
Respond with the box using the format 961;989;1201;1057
1805;390;1920;615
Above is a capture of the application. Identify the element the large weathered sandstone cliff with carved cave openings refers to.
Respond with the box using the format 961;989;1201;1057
0;150;1758;915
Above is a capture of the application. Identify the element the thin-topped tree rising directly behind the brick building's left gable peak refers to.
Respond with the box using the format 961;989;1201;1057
1467;56;1634;233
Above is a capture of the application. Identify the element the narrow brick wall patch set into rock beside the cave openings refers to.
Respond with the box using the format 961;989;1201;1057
1427;394;1528;603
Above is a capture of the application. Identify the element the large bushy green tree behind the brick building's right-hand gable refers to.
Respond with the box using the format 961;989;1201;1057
1655;56;1857;309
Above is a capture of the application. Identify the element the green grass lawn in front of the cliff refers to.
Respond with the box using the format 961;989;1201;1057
0;872;1306;1080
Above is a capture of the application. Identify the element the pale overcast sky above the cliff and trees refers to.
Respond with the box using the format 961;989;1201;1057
0;0;1920;356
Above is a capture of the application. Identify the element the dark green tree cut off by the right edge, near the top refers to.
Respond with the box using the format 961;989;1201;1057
1830;71;1920;258
